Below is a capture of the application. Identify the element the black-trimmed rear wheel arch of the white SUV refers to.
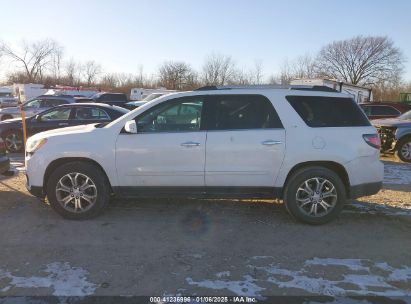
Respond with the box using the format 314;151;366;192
281;161;350;197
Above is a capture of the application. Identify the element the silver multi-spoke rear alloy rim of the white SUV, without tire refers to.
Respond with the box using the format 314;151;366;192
296;177;338;217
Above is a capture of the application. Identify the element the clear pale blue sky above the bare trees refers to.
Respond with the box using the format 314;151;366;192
0;0;411;80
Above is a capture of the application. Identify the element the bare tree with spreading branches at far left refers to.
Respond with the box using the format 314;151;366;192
0;39;62;82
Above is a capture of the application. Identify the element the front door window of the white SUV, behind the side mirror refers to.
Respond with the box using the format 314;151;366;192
136;96;203;133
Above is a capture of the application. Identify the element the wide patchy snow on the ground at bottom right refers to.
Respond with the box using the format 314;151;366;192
186;257;411;297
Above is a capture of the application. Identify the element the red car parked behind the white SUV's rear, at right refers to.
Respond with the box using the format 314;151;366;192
360;102;411;120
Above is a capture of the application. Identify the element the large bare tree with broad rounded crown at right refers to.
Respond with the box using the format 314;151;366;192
318;36;404;85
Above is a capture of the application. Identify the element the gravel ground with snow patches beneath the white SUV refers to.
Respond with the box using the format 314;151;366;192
0;157;411;303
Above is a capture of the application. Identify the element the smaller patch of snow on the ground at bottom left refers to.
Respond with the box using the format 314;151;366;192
0;262;97;296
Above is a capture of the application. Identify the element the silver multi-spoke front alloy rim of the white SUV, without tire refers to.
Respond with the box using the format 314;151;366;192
56;172;97;213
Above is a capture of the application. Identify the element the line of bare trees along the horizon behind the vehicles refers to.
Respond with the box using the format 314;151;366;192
0;36;411;100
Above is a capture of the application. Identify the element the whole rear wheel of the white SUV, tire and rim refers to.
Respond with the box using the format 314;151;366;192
284;167;347;225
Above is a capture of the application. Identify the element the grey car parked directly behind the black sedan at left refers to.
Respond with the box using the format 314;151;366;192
0;95;83;121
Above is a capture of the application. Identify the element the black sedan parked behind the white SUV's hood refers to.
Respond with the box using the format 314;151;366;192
0;103;129;152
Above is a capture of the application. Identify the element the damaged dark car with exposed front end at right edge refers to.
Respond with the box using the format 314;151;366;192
372;111;411;163
